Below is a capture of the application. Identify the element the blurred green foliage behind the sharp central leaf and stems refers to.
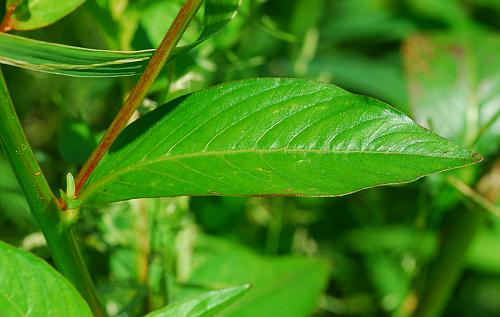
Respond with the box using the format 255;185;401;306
0;0;500;317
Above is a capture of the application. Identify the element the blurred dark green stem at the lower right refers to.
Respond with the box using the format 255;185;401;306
414;209;483;317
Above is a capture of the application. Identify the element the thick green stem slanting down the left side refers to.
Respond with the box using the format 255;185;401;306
0;69;105;316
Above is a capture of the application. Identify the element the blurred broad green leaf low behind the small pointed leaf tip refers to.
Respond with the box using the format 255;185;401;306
189;236;329;317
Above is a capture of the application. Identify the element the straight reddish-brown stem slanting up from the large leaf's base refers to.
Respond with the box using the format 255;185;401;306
75;0;203;196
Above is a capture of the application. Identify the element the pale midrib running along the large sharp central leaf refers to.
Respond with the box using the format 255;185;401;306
80;148;472;200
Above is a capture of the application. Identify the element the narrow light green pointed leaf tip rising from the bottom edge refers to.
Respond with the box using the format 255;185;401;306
145;284;250;317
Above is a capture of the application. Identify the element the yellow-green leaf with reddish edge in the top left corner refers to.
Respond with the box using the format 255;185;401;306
7;0;85;30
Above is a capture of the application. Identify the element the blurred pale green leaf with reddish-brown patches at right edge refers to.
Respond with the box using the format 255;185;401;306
405;32;500;154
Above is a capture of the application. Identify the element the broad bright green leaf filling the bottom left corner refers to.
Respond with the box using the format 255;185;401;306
0;241;92;317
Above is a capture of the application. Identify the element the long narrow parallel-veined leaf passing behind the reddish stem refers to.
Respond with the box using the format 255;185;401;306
0;0;238;77
